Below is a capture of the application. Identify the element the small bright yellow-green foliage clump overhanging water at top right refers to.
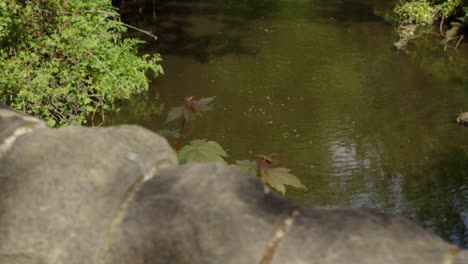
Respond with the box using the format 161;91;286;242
394;0;436;25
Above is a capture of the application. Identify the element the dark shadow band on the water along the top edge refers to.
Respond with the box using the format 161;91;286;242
119;0;388;63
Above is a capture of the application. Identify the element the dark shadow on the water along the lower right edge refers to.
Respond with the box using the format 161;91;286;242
404;148;468;248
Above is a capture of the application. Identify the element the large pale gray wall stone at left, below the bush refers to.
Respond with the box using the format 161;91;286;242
0;109;177;264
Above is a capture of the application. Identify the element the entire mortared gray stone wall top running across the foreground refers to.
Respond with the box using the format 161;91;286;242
0;107;468;264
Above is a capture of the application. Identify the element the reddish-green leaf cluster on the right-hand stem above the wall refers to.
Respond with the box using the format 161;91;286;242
235;154;307;195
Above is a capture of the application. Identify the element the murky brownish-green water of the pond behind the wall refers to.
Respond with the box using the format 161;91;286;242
112;0;468;246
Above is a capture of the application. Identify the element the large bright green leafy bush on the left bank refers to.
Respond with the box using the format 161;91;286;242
0;0;162;126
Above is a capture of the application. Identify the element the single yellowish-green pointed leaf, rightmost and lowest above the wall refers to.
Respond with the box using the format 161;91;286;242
261;168;307;195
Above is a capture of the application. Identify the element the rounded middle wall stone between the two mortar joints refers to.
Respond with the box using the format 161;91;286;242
106;164;297;264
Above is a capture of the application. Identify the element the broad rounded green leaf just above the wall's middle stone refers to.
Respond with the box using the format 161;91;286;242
178;139;228;163
